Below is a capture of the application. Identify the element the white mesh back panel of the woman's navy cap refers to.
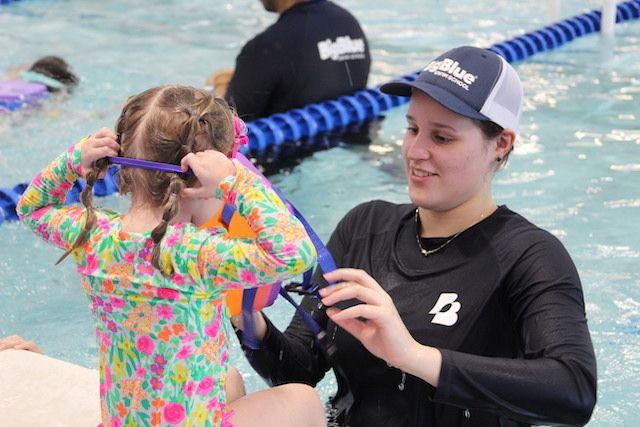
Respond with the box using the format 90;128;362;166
480;57;523;132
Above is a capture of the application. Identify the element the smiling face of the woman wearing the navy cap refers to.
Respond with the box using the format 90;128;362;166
402;90;499;216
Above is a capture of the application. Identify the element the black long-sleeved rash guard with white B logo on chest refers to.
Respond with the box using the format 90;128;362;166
238;201;596;427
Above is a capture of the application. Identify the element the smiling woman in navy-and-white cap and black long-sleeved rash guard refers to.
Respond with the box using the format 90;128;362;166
235;47;597;427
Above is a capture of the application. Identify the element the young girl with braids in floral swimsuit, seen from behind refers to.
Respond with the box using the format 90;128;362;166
18;86;325;427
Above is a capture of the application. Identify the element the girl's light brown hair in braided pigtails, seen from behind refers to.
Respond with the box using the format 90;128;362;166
58;86;234;275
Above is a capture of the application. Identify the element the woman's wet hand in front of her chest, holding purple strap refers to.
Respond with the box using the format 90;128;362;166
320;268;420;370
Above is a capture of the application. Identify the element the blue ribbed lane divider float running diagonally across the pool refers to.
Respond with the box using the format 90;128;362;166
0;0;640;223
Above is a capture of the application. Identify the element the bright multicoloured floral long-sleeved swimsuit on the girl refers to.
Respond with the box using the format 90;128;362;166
18;142;316;427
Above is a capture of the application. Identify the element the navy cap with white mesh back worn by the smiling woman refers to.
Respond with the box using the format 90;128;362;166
380;46;523;131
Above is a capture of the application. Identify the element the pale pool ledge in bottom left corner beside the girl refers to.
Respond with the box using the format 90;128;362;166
0;350;100;427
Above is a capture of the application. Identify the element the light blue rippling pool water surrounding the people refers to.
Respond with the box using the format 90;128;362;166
0;0;640;426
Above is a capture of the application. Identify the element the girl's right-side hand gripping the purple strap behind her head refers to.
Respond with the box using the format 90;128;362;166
180;150;236;199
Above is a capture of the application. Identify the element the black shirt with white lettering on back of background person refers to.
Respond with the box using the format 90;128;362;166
225;0;371;120
